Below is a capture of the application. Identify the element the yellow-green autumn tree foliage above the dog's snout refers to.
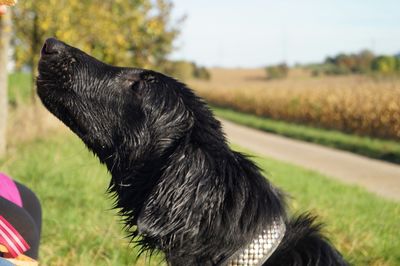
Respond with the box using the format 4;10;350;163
14;0;178;77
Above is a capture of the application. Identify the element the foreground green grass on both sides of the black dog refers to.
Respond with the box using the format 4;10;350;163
0;134;400;266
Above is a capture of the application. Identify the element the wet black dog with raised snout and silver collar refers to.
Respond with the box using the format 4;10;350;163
37;39;346;266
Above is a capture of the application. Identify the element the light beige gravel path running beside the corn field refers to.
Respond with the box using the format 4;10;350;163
221;120;400;201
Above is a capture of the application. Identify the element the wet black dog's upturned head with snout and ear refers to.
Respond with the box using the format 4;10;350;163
37;38;196;164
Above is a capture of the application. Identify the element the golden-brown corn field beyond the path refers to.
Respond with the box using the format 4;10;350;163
190;69;400;140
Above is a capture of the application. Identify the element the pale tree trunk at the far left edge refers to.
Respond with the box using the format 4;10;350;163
0;12;11;157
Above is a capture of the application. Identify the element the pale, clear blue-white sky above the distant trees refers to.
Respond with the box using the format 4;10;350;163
171;0;400;67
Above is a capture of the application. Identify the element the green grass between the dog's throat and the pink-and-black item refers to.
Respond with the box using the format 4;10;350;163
0;132;166;266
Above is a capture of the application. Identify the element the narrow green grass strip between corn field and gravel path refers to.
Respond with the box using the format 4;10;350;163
212;107;400;163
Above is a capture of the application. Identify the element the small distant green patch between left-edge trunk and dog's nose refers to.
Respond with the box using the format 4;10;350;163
8;72;32;106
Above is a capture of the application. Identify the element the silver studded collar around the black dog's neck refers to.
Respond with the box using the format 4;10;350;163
227;218;286;266
